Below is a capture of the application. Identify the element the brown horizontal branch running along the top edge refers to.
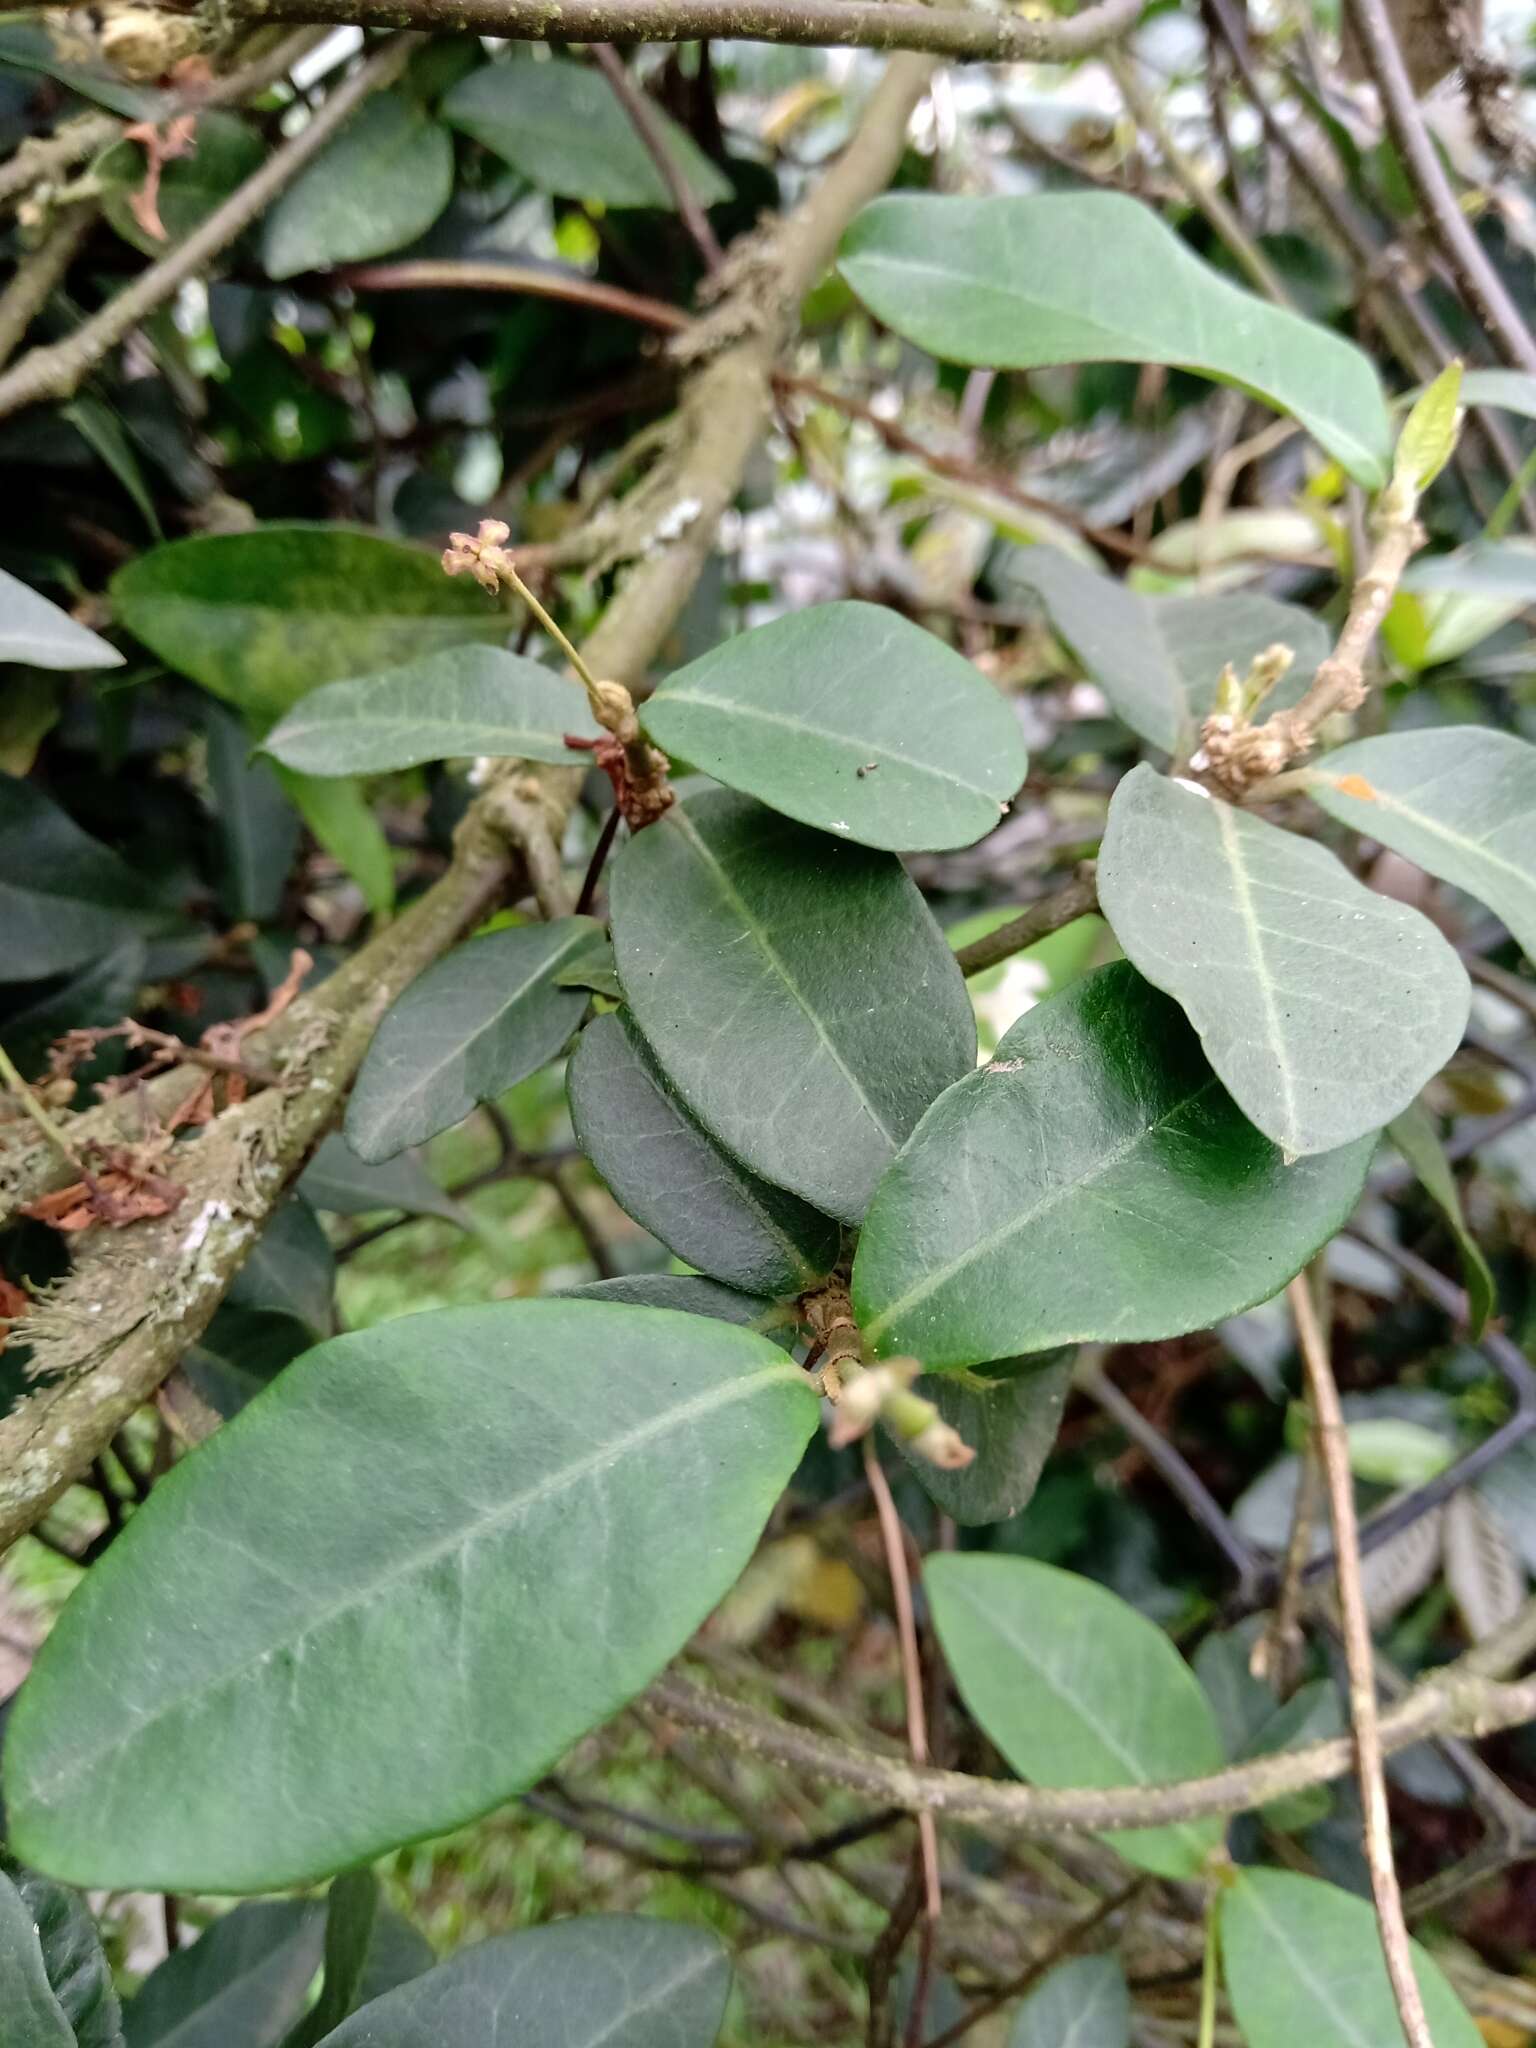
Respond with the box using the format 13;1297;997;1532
153;0;1143;63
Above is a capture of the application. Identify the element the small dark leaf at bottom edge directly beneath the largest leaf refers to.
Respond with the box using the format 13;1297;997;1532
123;1898;326;2048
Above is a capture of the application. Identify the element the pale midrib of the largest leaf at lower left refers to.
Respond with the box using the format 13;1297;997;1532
29;1358;805;1804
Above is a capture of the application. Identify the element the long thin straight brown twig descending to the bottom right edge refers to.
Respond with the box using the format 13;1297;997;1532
1286;1274;1434;2048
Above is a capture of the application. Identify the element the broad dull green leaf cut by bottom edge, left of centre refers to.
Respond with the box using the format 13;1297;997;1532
313;1913;731;2048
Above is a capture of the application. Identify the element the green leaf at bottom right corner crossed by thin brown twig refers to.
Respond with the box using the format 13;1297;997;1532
1221;1870;1483;2048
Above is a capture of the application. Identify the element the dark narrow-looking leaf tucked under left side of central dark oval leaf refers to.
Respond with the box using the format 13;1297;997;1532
565;1014;842;1296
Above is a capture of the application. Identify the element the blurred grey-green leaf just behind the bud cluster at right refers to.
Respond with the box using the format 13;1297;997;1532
1012;547;1333;754
